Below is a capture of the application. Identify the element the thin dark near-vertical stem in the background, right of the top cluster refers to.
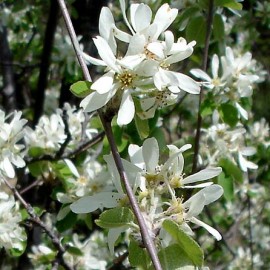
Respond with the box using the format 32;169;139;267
192;0;214;173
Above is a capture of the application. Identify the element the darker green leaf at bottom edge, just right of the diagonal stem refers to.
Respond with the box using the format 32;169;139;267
158;244;195;270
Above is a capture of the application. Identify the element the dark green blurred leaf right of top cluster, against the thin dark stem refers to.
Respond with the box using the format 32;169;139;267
186;16;206;46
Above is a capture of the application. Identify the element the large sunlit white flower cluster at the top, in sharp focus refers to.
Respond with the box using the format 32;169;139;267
81;0;200;125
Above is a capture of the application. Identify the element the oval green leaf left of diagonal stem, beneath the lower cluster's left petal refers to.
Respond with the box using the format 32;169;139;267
95;207;134;229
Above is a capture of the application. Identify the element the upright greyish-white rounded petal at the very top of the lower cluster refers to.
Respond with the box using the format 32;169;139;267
142;138;159;173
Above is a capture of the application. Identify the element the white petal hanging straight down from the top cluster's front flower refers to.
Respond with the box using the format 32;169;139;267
117;90;135;126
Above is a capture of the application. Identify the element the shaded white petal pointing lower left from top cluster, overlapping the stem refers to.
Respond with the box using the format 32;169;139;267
80;89;116;112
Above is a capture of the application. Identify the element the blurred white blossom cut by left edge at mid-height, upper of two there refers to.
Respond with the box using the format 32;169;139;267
0;110;27;178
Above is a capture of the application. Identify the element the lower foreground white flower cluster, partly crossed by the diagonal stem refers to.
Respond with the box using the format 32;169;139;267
71;138;223;252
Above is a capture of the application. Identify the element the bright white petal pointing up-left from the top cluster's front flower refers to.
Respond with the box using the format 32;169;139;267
93;36;121;73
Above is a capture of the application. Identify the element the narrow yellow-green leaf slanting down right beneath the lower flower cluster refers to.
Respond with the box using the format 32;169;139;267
162;220;203;267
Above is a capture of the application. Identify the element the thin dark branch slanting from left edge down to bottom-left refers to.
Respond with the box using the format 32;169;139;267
3;178;73;270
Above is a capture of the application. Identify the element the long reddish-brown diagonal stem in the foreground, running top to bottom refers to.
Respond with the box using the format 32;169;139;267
58;0;162;270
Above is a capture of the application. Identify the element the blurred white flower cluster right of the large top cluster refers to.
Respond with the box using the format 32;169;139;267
191;47;262;120
